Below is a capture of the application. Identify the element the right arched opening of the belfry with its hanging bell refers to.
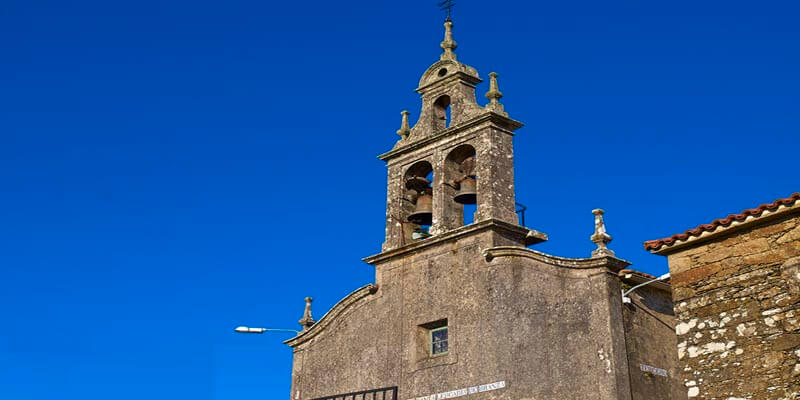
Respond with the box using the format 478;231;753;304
445;144;478;227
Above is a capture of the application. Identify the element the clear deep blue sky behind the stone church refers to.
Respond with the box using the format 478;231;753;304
0;0;800;400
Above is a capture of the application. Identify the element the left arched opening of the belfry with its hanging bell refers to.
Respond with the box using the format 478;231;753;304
401;161;433;242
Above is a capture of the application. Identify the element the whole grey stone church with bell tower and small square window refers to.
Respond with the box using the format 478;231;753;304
286;20;685;400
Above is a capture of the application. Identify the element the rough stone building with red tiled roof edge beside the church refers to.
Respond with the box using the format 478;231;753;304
645;193;800;400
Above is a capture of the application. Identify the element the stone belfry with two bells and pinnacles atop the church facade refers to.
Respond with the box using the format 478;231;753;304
379;20;536;251
